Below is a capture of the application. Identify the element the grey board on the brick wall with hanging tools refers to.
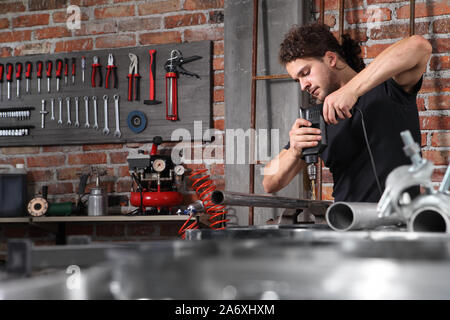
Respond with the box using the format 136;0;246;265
0;41;212;146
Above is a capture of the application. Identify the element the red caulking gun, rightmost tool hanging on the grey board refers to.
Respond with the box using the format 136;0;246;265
164;50;202;121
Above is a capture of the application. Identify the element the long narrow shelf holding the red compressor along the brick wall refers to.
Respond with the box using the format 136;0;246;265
0;215;189;223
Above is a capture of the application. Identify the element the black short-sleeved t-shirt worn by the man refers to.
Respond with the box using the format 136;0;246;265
285;78;422;202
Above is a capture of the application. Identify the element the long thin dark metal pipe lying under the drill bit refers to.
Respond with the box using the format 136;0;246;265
211;190;331;209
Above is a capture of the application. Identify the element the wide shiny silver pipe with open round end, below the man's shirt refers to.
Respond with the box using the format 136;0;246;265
325;202;404;231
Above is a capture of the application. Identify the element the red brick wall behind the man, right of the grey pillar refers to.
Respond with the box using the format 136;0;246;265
314;0;450;199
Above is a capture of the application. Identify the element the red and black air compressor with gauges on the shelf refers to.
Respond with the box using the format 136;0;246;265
127;136;185;214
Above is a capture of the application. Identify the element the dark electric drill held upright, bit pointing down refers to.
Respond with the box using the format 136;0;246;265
299;104;327;181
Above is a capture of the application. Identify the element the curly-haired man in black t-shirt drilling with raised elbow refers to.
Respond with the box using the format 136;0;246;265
263;24;431;202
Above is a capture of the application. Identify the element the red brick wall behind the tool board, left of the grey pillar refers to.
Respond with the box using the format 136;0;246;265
0;0;224;241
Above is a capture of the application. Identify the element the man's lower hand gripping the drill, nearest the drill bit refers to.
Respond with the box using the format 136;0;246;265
289;118;322;157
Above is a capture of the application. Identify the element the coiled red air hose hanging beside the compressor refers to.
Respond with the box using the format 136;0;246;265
178;169;229;239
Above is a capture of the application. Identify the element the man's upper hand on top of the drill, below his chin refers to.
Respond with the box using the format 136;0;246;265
323;86;358;124
